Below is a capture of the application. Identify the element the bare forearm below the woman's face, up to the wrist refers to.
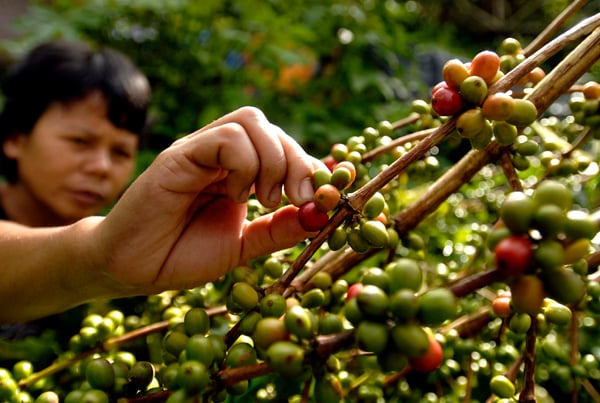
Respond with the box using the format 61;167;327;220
0;217;126;323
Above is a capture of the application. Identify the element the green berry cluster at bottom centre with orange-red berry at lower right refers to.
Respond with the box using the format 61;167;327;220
343;258;458;372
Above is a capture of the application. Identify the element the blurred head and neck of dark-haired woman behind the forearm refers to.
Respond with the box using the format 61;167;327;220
0;41;150;227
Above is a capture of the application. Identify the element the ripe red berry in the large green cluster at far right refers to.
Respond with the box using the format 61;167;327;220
494;236;534;276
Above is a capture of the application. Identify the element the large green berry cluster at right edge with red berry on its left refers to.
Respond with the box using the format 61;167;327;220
490;180;598;315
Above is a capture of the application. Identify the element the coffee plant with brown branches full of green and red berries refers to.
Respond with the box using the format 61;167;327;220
0;4;600;403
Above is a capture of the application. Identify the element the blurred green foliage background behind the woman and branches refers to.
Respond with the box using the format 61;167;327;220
0;0;598;164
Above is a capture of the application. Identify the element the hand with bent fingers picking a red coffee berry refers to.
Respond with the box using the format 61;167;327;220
96;108;323;294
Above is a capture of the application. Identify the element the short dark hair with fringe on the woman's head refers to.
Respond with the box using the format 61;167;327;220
0;40;150;182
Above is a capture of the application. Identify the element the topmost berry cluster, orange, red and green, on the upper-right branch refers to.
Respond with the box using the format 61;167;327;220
431;50;537;148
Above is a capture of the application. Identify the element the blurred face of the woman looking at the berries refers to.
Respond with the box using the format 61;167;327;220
4;93;139;222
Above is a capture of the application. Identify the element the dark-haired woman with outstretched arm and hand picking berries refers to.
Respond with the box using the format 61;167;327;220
0;42;322;323
